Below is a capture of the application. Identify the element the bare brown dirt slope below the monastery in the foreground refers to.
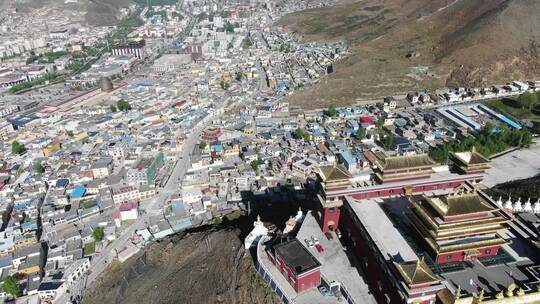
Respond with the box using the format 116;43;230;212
83;229;281;304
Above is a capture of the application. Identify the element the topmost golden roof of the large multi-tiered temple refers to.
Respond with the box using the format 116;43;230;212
426;191;497;216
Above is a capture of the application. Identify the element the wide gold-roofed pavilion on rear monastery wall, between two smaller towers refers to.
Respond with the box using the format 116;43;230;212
373;152;435;183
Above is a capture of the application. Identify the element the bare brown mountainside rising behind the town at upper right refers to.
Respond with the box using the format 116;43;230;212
279;0;540;109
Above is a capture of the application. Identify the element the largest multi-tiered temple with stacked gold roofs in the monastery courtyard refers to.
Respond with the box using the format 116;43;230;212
409;187;508;264
